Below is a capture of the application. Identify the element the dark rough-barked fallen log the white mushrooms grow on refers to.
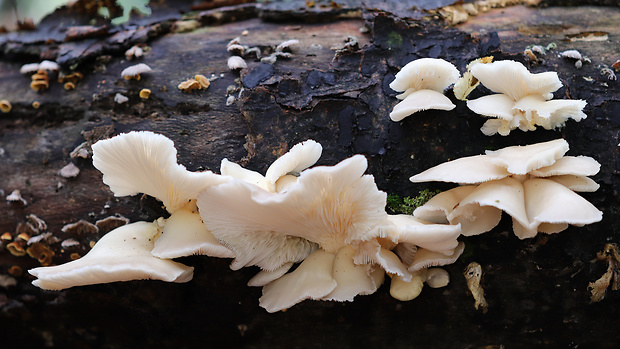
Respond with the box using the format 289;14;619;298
0;1;620;348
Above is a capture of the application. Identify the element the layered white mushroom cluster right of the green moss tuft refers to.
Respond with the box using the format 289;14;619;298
410;139;602;239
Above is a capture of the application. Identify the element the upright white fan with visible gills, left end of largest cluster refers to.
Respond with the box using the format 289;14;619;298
92;131;228;213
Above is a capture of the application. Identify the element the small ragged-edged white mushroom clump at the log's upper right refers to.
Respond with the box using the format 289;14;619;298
467;60;586;136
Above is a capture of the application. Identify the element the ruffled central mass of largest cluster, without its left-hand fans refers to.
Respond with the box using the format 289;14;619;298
197;148;460;312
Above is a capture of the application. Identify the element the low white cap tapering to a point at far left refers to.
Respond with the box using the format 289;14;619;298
29;222;194;290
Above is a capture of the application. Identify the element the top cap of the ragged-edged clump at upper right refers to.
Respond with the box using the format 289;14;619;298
471;60;562;101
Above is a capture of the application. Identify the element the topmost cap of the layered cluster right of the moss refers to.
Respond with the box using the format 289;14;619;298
486;138;568;175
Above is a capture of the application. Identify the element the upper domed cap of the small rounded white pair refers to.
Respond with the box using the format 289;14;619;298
390;58;460;99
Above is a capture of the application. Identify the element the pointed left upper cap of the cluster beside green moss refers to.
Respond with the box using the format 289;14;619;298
409;155;510;184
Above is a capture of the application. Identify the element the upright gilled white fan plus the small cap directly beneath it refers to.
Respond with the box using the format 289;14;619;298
92;131;233;258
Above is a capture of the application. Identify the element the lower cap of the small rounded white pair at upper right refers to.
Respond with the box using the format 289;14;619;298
390;89;456;121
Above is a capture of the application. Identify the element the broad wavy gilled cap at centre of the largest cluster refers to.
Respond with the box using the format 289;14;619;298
198;155;387;258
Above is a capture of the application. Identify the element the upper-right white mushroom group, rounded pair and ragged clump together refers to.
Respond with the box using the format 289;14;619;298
390;58;586;136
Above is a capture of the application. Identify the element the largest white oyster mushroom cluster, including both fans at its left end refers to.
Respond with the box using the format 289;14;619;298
30;132;464;312
